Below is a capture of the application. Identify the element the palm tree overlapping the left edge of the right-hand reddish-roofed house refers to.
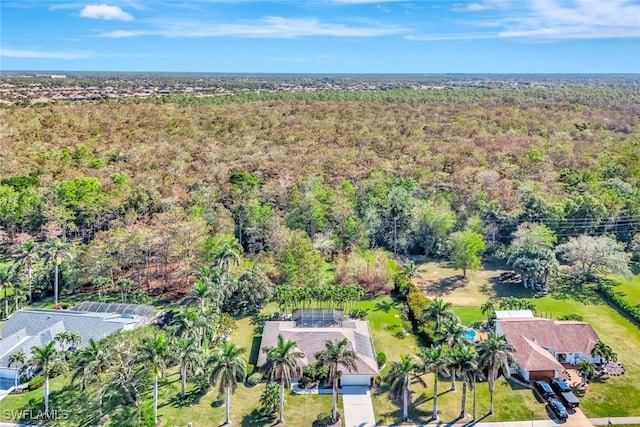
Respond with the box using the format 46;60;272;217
478;332;515;414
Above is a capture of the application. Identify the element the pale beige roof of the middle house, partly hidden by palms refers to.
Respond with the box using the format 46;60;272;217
256;320;380;375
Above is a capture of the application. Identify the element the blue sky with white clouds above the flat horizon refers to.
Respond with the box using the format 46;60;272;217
0;0;640;73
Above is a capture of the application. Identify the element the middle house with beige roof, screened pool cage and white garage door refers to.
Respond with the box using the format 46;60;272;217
256;309;380;386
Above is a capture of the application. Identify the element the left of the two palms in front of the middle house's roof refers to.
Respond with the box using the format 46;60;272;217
262;334;304;423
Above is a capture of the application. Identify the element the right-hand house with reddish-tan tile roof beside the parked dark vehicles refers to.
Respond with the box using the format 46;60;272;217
496;315;599;381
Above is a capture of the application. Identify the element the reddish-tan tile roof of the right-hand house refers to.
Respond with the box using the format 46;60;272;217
498;317;599;371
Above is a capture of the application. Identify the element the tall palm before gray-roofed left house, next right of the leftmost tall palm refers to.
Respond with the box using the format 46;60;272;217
71;338;110;419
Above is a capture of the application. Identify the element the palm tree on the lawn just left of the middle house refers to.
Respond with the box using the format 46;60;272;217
207;342;247;424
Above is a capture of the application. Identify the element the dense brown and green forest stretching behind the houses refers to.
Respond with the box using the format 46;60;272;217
0;86;640;302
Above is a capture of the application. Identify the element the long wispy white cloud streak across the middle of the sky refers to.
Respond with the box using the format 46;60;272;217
99;16;407;39
